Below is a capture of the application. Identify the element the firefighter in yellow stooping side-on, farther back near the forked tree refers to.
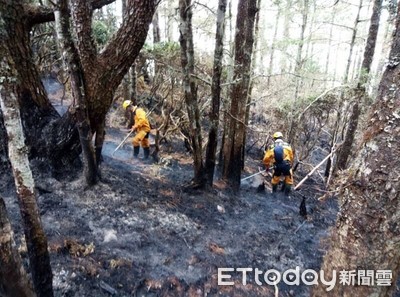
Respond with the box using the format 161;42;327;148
122;100;151;159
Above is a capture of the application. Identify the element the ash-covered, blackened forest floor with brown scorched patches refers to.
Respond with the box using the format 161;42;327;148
0;130;337;297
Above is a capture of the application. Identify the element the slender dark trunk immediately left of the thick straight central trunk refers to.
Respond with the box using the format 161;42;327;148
205;0;226;186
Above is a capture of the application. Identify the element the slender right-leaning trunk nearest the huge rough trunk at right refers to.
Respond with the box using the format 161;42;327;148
337;0;382;170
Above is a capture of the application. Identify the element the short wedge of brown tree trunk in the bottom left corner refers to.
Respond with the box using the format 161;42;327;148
0;197;36;297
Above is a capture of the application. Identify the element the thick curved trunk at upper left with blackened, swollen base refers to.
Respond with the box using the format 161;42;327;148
0;0;79;169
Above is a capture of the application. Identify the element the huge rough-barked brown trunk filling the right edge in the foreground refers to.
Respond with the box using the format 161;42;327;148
312;2;400;297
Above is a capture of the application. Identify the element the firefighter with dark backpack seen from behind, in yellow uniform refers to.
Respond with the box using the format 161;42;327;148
263;132;294;195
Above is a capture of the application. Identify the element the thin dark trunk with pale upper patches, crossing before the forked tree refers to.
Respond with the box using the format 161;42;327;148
55;0;97;186
